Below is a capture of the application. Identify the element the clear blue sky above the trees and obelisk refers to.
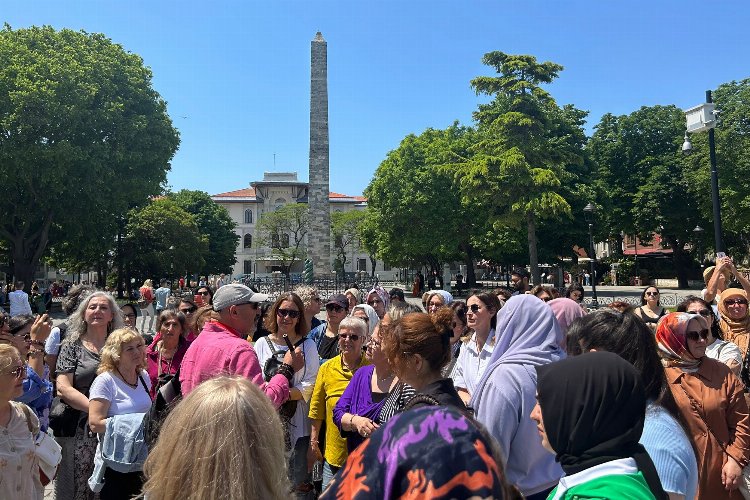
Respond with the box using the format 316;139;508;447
0;0;750;195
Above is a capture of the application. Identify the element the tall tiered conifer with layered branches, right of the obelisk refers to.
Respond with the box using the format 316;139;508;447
452;51;585;283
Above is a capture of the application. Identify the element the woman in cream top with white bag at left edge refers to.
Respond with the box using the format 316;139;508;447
0;344;44;500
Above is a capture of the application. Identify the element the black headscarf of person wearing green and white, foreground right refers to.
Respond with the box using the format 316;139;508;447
536;352;667;499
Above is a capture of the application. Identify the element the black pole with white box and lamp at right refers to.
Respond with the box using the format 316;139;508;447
682;90;725;253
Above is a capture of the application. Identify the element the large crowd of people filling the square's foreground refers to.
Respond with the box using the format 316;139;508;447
0;259;750;500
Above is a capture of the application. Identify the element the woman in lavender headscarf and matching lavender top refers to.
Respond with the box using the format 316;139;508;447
470;294;565;500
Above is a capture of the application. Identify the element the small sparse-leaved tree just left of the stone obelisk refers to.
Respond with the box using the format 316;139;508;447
255;203;310;276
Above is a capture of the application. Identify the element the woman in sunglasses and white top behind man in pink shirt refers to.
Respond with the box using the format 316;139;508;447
255;293;320;498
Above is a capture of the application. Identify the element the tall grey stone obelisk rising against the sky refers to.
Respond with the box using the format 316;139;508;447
307;31;331;276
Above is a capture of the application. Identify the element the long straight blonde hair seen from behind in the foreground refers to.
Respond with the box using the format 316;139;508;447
143;377;290;500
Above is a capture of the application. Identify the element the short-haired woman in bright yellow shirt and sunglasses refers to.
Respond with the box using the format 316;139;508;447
308;316;367;490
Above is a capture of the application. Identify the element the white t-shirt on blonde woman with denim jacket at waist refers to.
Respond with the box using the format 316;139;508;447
89;370;151;417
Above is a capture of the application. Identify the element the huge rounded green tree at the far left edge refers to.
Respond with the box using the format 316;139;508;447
0;25;179;292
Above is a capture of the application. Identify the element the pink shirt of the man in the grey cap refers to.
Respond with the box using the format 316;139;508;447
180;321;289;408
